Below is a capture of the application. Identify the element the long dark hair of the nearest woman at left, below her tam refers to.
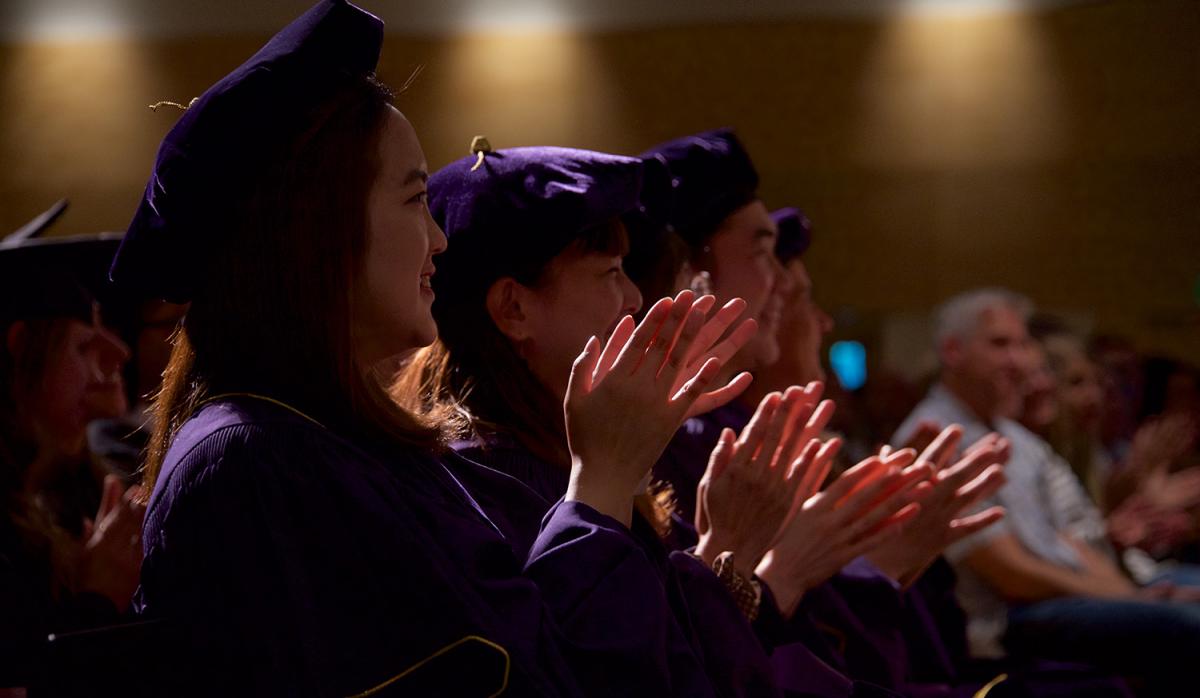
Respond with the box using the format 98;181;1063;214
145;77;438;495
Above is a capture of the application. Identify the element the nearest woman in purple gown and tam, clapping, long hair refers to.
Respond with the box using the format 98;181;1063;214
110;0;768;696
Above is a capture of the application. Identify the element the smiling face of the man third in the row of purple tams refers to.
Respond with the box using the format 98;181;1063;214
698;200;792;368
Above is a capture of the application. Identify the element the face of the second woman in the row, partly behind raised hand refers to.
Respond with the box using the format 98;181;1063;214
518;232;642;398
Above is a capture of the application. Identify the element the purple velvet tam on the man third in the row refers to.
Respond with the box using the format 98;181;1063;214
642;128;758;245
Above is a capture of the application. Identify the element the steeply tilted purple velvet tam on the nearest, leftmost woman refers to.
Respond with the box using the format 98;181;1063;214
109;0;383;302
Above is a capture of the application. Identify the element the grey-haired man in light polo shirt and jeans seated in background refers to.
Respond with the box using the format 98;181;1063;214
896;289;1200;692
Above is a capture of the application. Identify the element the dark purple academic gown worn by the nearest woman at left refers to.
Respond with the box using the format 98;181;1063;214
136;398;700;696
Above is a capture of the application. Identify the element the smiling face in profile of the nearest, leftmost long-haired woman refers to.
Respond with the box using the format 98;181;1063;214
353;108;446;366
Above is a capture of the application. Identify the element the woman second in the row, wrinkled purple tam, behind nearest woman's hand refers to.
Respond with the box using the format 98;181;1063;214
394;148;774;696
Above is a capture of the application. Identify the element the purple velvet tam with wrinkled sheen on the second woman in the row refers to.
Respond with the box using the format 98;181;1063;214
428;146;643;303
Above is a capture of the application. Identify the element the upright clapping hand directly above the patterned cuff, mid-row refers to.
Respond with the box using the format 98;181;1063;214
696;383;840;577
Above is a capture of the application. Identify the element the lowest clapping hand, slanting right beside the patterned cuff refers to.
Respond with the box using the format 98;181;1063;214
756;449;931;615
